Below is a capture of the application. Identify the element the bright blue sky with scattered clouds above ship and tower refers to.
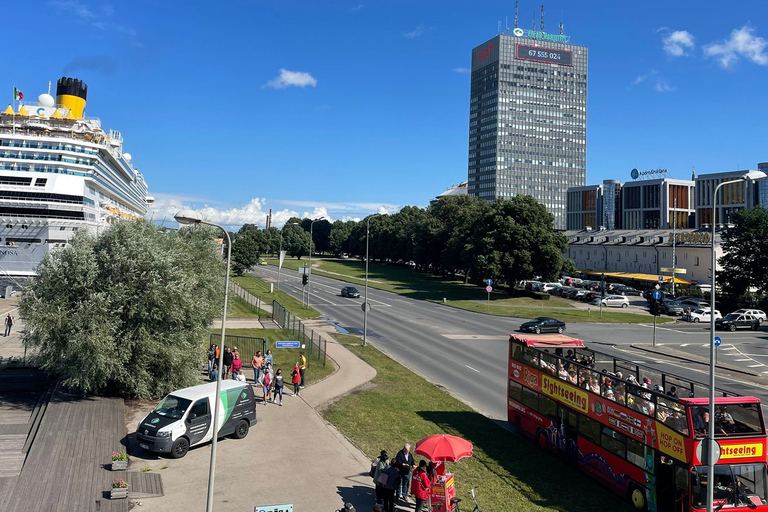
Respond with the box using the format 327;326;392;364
6;0;768;226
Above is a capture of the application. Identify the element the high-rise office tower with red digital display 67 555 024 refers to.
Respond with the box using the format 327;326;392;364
468;26;587;229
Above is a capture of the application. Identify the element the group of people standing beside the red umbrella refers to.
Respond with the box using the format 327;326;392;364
370;444;438;512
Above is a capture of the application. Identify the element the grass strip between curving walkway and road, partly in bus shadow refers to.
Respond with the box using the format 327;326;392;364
324;335;629;512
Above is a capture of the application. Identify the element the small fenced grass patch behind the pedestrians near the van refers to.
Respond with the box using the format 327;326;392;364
216;329;336;384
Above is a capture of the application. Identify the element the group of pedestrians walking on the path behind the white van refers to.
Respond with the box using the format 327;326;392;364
208;344;307;405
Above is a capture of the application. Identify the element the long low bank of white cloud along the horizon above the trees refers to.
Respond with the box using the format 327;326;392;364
147;193;401;230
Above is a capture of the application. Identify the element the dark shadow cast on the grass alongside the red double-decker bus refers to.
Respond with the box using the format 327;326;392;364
417;411;629;512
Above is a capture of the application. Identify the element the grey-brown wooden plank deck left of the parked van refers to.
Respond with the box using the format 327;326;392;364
0;389;163;512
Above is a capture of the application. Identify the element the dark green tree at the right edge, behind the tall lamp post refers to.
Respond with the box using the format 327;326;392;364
716;207;768;297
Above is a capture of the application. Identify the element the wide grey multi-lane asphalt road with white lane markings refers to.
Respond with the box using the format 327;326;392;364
253;266;768;420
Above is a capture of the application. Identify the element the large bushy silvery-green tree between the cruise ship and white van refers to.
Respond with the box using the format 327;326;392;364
20;221;224;398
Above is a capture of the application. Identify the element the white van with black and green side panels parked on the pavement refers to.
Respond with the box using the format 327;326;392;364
136;380;256;459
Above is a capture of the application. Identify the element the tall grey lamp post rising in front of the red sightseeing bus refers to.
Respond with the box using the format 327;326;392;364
706;171;766;512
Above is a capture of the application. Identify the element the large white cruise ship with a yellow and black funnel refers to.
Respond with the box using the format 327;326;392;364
0;77;153;278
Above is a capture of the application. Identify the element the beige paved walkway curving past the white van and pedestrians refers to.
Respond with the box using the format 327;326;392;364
126;321;380;512
